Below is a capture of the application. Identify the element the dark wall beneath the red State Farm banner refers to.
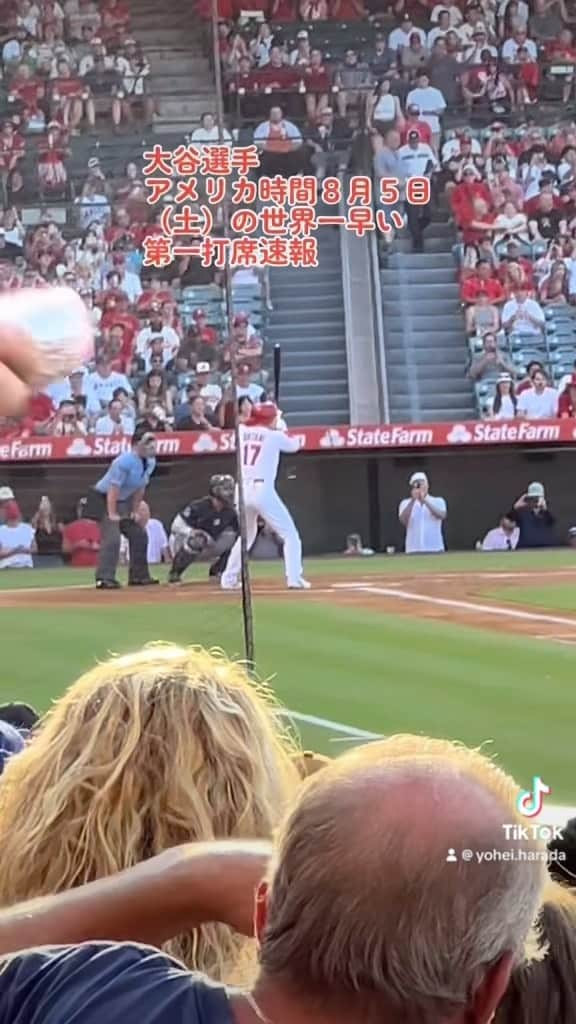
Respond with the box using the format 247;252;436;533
0;449;576;554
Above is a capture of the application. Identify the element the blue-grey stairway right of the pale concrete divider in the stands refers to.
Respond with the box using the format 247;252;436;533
380;221;476;423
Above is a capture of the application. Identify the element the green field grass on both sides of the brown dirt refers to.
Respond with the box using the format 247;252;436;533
0;552;576;803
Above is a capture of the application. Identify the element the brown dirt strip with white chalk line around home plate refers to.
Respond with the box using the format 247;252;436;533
0;563;576;645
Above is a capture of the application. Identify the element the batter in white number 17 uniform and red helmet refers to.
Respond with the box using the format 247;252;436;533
220;401;310;590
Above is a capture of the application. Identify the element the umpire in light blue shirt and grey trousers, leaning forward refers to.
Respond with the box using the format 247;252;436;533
87;428;158;590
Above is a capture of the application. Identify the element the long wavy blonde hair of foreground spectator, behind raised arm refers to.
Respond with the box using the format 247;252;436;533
0;644;298;983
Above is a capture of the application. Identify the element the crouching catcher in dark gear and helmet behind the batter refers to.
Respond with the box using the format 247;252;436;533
168;473;240;583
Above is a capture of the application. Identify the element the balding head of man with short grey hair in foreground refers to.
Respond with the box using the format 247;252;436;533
261;736;545;1024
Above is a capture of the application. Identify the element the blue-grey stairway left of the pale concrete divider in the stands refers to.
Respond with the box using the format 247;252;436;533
266;227;349;426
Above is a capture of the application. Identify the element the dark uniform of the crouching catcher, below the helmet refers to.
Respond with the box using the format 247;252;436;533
168;496;240;583
